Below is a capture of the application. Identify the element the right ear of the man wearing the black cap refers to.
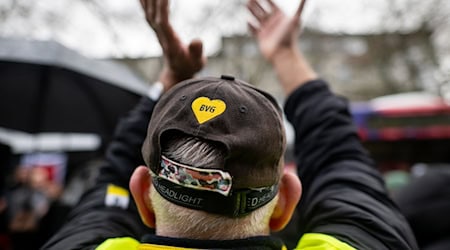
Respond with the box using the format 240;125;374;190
270;169;302;232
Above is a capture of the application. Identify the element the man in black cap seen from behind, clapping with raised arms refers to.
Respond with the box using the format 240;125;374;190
44;0;417;249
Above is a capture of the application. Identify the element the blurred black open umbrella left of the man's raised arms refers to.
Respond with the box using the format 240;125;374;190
0;38;145;151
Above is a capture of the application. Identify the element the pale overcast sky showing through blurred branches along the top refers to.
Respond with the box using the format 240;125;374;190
0;0;444;58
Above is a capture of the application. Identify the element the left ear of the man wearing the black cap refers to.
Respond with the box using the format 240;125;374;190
130;166;155;228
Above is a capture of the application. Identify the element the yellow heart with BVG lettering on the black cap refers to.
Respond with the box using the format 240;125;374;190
191;97;227;124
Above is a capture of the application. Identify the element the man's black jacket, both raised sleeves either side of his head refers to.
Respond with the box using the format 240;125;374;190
43;81;417;250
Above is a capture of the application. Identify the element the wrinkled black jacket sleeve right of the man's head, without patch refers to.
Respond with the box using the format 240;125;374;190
285;80;417;249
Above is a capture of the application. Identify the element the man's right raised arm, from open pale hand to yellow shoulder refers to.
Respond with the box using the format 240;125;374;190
248;0;417;249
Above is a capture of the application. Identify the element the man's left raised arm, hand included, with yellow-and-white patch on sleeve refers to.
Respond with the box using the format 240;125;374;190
42;0;206;249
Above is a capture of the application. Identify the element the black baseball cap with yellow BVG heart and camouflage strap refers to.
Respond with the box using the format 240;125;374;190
142;76;286;217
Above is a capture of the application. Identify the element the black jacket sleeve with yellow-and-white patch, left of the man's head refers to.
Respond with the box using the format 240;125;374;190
42;97;155;249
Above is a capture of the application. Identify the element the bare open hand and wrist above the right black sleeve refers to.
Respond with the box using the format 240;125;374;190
247;0;317;95
